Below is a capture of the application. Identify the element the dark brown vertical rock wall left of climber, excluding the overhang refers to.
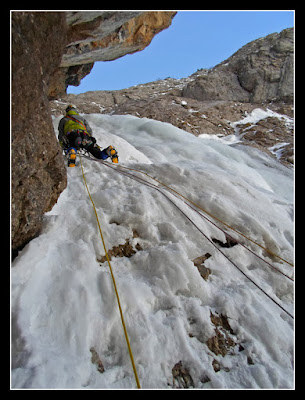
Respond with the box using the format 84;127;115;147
11;12;66;256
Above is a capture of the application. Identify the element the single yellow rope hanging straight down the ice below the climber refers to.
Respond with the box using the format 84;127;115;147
79;156;141;389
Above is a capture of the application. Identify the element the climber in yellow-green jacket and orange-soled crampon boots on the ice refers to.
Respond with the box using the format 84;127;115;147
58;104;118;167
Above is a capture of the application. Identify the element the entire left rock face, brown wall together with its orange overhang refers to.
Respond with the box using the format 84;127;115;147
11;11;176;255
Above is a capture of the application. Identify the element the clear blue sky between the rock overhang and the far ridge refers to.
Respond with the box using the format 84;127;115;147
67;11;294;94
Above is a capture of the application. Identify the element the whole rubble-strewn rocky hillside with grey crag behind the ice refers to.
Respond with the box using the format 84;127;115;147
52;28;294;165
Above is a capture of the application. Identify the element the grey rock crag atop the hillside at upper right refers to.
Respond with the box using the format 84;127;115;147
182;28;294;103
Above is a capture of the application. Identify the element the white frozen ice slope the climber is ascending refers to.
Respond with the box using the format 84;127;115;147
11;114;294;388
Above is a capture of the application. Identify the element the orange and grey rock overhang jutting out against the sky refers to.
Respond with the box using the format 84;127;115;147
49;11;176;99
